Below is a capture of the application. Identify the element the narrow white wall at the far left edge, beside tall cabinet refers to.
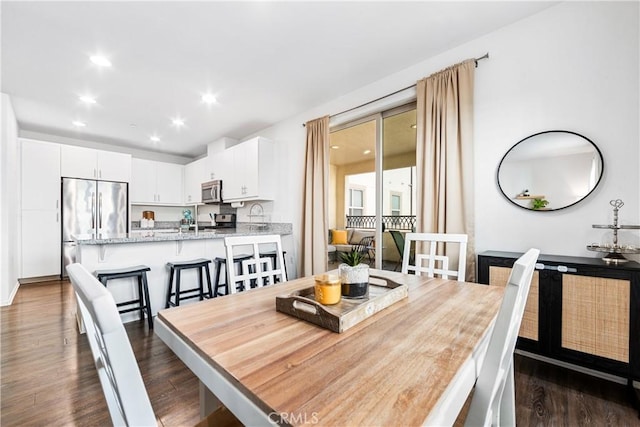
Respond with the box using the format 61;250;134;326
0;93;21;305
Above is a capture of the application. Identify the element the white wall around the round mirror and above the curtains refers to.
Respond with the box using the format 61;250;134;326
248;2;640;270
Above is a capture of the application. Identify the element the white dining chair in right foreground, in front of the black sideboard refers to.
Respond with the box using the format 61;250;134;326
465;249;540;426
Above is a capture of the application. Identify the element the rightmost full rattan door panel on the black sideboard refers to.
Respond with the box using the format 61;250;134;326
561;274;631;363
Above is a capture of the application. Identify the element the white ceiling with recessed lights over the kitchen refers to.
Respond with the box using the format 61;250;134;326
0;0;555;157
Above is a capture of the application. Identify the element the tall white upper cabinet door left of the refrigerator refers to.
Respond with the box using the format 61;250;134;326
21;139;60;210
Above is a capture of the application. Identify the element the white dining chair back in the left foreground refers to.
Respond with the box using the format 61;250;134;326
67;263;157;426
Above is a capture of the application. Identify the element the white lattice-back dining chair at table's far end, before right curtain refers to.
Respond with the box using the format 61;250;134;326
402;233;468;281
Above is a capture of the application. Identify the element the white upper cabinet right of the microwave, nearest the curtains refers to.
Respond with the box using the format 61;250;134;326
222;137;277;202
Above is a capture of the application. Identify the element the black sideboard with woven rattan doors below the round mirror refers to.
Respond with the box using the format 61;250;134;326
477;251;640;381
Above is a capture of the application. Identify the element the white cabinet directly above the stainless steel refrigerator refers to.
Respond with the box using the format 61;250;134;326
60;145;131;182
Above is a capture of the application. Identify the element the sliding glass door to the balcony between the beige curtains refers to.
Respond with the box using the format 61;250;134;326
329;104;416;270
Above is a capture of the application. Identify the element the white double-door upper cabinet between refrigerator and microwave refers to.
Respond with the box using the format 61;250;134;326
129;159;183;205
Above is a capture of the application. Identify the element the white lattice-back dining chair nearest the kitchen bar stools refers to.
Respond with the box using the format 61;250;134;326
224;234;287;294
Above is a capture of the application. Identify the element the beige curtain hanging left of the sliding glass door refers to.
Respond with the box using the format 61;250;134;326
301;116;329;276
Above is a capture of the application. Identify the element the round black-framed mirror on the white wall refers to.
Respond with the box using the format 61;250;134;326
498;130;604;211
